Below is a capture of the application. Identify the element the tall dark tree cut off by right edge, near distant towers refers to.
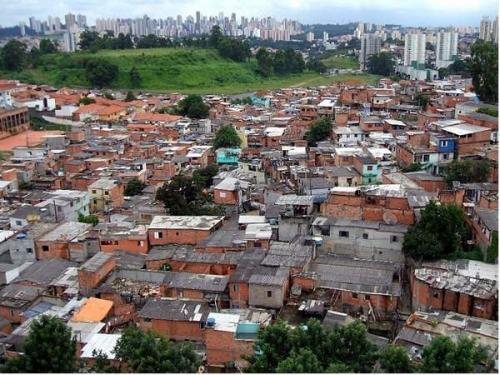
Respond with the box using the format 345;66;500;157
469;39;498;103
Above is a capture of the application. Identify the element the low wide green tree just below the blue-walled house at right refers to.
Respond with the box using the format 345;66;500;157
444;159;491;185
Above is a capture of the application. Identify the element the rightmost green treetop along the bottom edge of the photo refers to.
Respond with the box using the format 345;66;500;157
419;336;487;373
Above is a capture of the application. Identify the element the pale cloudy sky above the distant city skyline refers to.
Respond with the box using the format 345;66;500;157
0;0;498;26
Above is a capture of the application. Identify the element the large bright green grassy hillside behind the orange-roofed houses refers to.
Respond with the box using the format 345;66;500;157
0;48;377;94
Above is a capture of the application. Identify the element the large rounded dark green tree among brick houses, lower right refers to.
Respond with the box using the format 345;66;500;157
403;201;469;260
